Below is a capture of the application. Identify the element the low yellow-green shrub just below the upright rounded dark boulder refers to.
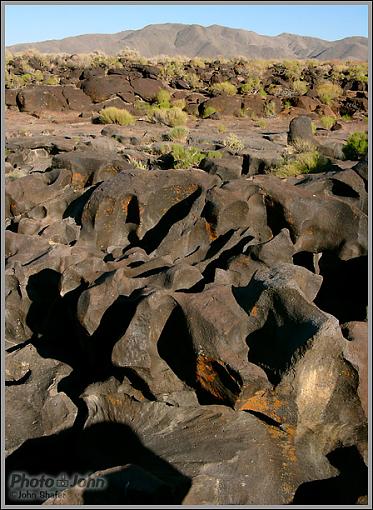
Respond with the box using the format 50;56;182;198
271;149;330;177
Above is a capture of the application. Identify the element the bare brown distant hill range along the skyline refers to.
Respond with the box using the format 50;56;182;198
7;23;368;60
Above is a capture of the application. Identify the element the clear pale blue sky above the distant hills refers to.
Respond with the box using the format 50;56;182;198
5;2;368;46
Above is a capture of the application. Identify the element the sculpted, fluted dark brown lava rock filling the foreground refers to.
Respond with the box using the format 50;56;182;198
5;109;368;506
